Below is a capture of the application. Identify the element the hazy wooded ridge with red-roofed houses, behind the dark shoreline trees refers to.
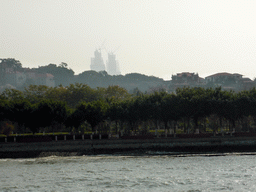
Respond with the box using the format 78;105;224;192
0;58;256;93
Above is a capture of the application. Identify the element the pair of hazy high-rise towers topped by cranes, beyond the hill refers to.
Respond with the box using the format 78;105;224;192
90;49;121;75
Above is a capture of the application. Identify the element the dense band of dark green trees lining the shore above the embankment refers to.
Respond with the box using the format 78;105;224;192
0;84;256;135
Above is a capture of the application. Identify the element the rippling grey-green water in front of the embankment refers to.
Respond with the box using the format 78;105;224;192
0;153;256;191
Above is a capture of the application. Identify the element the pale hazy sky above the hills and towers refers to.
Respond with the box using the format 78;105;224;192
0;0;256;78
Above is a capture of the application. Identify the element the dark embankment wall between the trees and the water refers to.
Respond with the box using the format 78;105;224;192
0;137;256;158
